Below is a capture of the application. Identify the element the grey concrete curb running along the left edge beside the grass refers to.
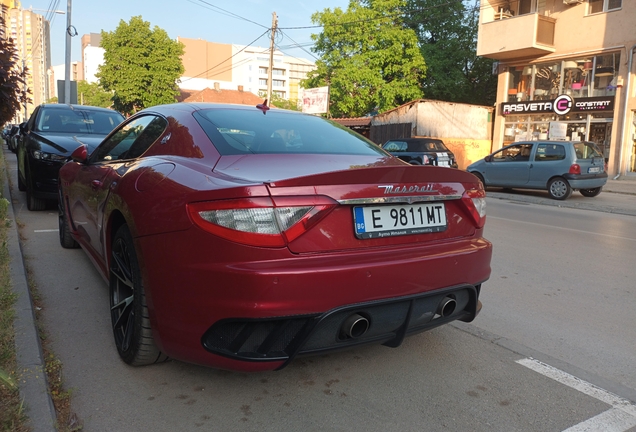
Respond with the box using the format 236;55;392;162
2;149;57;432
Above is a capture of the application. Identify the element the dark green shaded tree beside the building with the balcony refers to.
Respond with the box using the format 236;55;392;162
408;0;497;105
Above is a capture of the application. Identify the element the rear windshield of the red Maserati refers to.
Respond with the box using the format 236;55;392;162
194;108;384;156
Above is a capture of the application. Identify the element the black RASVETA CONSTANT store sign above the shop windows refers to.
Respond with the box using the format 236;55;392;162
501;95;614;115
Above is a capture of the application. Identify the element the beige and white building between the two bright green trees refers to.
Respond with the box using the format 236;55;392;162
178;37;316;103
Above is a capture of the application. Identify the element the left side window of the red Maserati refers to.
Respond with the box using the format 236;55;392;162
91;115;168;163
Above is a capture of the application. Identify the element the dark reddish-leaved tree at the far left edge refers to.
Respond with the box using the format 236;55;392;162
0;16;28;125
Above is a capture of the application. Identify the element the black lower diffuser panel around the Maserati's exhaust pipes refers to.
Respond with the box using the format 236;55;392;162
201;285;481;369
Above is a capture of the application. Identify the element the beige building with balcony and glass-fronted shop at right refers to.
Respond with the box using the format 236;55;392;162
477;0;636;176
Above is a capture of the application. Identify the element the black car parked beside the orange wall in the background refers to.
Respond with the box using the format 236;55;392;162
382;137;457;168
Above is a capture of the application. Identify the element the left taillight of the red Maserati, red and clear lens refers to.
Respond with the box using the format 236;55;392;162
188;196;336;247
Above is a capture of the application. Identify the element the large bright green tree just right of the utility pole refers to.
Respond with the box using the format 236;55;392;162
302;0;426;117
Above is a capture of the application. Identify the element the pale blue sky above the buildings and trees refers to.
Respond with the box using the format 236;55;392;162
22;0;349;66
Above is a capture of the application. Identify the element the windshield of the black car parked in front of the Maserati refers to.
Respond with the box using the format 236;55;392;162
35;108;124;135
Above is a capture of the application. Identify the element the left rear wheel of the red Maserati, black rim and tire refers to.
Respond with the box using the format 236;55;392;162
109;225;167;366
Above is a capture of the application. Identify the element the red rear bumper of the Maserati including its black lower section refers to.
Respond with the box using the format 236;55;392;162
138;229;492;371
